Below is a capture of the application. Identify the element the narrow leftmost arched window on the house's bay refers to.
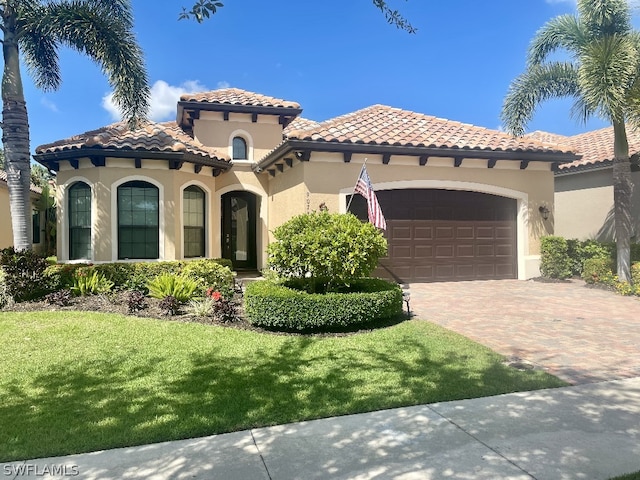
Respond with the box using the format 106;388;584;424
68;182;91;260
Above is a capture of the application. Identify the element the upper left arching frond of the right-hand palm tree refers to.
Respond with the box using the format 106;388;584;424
527;15;587;66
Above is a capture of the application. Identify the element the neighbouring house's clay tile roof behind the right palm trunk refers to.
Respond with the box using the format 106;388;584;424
558;127;640;170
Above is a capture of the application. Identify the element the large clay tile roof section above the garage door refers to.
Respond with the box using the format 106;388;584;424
287;105;571;153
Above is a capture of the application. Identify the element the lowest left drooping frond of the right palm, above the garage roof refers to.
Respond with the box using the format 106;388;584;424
500;62;580;136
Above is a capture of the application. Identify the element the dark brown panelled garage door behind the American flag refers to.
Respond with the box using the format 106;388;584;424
350;189;518;282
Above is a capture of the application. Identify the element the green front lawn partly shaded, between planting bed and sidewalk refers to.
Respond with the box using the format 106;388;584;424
0;312;565;462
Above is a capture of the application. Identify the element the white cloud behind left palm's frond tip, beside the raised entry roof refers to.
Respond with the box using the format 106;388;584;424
102;80;207;122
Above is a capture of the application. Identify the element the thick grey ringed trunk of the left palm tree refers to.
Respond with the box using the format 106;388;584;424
2;7;33;250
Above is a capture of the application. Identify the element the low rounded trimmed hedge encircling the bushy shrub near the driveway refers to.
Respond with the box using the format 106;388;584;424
245;278;402;331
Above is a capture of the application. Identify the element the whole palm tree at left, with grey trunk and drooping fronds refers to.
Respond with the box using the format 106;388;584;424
0;0;149;250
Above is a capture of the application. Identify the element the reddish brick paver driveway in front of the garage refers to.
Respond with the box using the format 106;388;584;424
409;280;640;384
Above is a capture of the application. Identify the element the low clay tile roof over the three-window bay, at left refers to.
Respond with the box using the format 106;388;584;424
36;122;229;161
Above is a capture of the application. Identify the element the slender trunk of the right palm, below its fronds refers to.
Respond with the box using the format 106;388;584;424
613;122;633;282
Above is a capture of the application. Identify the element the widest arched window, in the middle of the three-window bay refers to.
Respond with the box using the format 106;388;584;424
118;181;160;259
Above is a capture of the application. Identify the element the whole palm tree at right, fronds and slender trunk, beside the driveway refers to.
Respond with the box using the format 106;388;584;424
501;0;640;281
